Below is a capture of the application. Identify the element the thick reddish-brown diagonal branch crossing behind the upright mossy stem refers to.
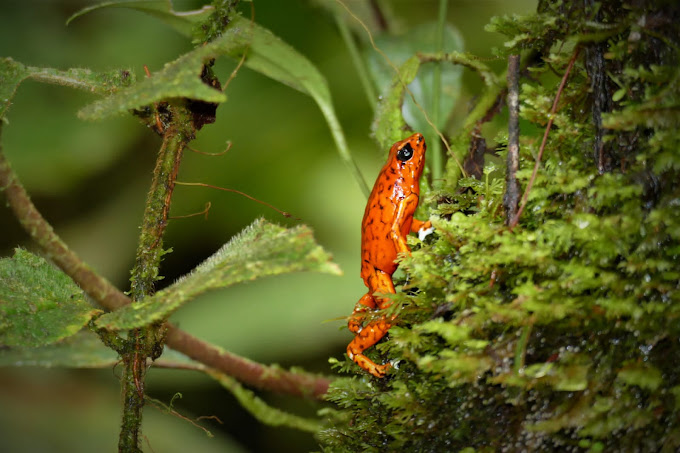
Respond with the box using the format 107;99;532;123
0;121;330;399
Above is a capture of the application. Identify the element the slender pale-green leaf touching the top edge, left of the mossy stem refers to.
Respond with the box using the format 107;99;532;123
66;0;214;38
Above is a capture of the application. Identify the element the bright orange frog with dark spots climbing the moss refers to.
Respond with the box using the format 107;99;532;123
347;133;432;377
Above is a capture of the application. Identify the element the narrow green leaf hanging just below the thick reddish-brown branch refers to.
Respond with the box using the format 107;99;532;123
207;370;321;433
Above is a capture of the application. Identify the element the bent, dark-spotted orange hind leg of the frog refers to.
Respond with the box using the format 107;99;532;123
347;269;394;377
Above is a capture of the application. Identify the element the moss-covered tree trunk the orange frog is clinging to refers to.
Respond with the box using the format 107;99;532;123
320;0;680;452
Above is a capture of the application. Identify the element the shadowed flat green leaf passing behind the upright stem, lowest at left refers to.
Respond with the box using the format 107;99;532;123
0;329;204;370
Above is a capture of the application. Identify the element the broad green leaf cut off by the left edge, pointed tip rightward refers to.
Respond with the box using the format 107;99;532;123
0;249;101;347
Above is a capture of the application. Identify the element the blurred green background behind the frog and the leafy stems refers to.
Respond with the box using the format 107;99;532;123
0;0;535;452
